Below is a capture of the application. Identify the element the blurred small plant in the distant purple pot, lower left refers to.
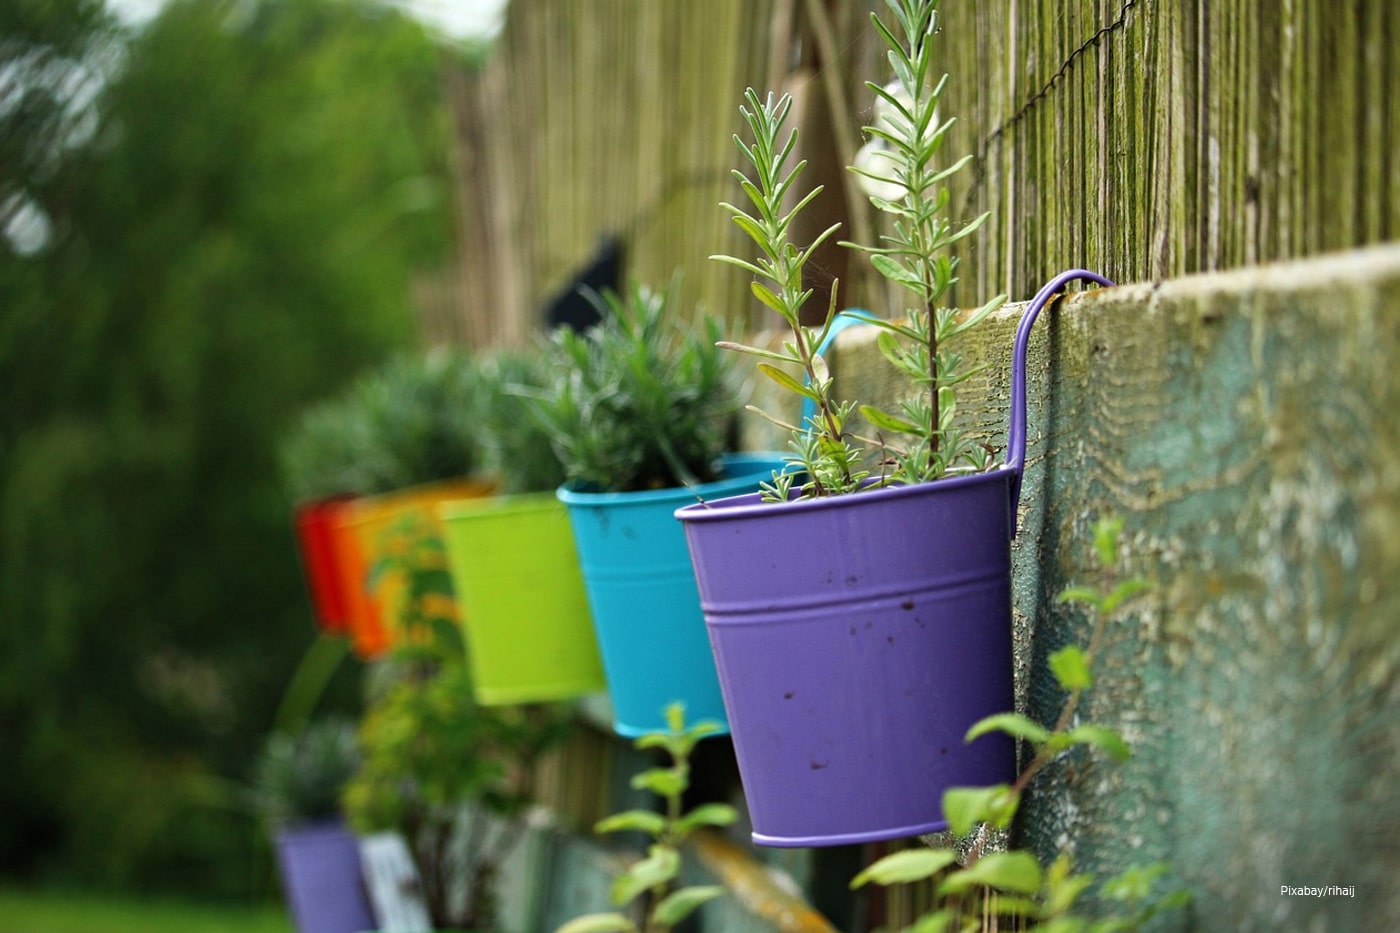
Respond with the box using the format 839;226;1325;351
253;717;360;828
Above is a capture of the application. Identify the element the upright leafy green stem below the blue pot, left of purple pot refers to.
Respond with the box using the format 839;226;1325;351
557;703;738;933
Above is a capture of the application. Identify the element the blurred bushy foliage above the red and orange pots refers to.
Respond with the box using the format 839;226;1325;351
280;349;483;502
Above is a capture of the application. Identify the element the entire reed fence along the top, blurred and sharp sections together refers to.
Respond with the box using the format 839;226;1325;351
421;0;1400;346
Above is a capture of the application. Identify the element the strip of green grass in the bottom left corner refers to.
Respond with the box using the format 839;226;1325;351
0;888;293;933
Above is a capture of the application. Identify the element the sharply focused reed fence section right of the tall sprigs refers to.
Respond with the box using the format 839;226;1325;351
944;0;1400;298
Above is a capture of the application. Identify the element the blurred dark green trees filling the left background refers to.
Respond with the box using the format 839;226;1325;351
0;0;461;895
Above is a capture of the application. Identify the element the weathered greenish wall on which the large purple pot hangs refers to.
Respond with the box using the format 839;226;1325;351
800;245;1400;932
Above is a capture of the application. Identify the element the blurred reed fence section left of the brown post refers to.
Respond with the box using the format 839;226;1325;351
422;0;771;345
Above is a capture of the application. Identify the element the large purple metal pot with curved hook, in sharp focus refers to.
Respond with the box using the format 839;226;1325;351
676;270;1112;846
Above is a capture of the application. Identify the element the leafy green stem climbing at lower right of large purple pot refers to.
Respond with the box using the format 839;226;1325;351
851;518;1190;933
